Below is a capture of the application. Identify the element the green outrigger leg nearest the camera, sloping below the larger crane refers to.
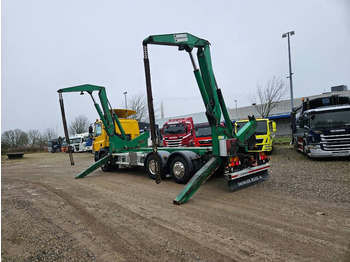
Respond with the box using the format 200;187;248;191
173;157;221;205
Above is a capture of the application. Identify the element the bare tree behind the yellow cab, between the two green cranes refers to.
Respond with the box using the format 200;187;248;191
121;93;149;122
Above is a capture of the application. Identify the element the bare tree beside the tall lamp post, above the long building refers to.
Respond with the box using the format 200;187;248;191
248;76;288;117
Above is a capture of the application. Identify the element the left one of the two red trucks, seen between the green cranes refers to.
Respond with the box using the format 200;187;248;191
162;117;196;147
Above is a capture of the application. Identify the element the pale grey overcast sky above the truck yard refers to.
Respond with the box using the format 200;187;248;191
1;0;350;136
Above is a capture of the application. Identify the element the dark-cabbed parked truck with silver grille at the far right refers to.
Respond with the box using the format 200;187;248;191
291;95;350;158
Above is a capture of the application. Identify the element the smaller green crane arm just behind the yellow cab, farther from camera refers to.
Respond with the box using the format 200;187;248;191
57;84;127;140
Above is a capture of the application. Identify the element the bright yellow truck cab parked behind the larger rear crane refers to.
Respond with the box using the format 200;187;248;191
235;118;276;153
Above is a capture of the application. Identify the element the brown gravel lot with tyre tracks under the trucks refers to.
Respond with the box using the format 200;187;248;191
1;146;350;261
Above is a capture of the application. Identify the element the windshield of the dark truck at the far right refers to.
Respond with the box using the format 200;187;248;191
310;109;350;128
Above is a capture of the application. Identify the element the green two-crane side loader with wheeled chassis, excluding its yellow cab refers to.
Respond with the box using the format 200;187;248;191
58;33;270;205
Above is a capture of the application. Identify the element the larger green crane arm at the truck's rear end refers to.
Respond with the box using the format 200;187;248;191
143;33;256;156
